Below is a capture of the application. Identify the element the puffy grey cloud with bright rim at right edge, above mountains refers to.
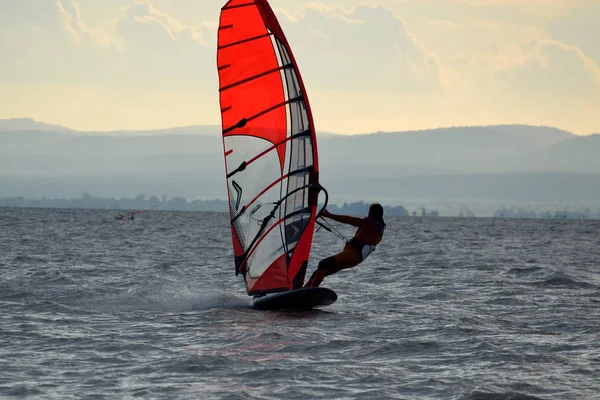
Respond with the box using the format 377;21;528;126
487;40;600;134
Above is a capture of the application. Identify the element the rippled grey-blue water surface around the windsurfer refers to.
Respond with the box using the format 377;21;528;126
0;208;600;399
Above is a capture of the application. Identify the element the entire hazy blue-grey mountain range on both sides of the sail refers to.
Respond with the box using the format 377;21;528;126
0;120;600;205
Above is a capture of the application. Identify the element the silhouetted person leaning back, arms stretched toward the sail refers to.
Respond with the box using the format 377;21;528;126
304;203;385;288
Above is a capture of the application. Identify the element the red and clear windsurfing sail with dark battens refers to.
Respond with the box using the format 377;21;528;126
217;0;322;295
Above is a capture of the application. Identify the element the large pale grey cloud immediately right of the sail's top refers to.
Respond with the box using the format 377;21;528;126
280;3;443;94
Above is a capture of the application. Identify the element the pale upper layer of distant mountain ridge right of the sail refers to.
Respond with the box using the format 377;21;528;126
319;125;574;173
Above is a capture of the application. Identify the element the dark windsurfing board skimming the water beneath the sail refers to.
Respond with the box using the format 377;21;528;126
252;287;337;310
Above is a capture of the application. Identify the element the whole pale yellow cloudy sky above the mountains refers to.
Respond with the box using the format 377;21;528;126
0;0;600;135
